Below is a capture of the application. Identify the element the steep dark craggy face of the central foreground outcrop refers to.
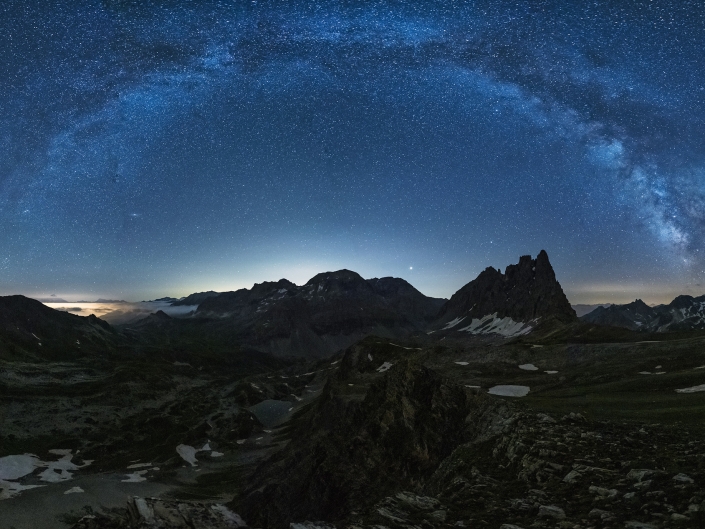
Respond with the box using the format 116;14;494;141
231;350;469;528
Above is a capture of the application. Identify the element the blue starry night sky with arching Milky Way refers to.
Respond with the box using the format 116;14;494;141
0;0;705;303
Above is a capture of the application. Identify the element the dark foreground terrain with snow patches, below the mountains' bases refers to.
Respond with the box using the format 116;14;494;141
0;328;705;529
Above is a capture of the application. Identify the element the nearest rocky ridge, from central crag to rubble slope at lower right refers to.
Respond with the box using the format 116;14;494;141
62;340;705;529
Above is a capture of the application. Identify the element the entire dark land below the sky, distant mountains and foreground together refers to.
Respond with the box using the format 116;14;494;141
0;251;705;529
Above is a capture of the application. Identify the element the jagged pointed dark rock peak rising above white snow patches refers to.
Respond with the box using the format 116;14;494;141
436;250;577;327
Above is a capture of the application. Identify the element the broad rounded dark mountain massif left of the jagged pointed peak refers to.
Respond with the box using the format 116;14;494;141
177;270;445;357
